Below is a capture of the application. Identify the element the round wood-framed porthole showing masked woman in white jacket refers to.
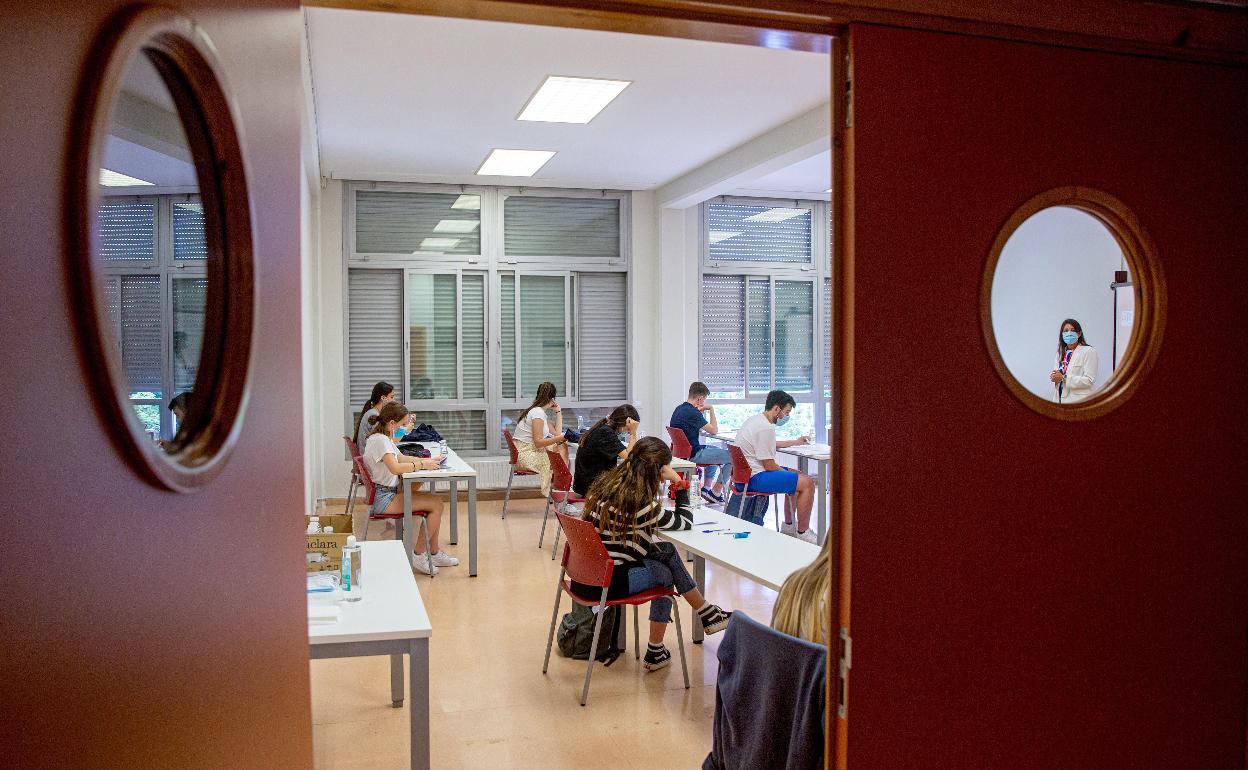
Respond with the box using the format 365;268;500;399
981;187;1166;419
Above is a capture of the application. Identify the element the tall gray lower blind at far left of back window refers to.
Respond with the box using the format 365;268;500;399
347;270;403;409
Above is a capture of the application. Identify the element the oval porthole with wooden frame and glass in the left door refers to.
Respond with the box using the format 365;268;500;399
66;6;255;492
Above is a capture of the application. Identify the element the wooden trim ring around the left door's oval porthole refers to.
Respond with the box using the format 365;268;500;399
65;5;256;492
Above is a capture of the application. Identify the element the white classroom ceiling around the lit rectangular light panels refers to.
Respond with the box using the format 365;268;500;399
305;9;831;193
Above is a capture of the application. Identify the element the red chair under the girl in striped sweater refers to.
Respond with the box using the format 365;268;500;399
542;513;689;705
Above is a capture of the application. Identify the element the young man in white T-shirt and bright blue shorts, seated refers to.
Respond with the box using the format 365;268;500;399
735;391;819;543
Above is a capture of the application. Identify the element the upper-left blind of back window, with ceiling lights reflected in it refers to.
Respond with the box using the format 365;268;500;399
356;190;480;256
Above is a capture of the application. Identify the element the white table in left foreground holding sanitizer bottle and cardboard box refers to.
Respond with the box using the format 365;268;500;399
308;540;433;770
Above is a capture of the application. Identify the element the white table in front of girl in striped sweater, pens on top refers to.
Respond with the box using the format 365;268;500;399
658;507;819;644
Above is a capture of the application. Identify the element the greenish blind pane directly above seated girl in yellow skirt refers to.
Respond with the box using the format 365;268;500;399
520;275;568;397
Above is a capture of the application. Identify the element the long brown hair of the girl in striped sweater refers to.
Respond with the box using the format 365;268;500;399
582;436;671;540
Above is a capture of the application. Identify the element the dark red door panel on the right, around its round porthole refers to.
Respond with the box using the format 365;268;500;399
847;26;1248;769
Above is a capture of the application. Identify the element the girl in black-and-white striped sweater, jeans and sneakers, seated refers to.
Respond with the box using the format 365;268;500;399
573;437;731;671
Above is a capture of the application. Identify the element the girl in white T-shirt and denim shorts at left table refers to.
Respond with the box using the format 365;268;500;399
364;401;459;574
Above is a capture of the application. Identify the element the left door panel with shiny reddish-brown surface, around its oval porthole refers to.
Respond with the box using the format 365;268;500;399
0;0;312;768
